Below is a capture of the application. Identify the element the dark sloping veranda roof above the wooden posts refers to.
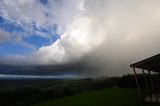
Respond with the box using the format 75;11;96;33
130;54;160;72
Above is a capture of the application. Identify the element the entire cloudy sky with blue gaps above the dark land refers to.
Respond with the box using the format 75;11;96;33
0;0;160;77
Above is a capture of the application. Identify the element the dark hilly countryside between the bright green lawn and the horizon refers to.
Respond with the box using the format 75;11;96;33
0;78;119;106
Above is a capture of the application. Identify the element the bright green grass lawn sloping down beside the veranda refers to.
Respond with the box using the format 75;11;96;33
33;88;159;106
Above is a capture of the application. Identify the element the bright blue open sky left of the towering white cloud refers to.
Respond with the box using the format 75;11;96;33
0;15;60;56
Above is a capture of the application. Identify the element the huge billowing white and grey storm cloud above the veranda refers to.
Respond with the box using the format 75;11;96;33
0;0;160;76
